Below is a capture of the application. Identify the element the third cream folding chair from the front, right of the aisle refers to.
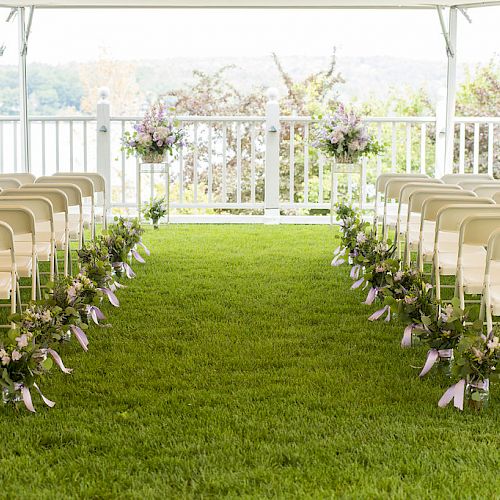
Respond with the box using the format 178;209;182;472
432;203;500;301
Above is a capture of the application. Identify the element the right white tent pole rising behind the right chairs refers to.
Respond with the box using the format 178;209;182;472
444;7;458;174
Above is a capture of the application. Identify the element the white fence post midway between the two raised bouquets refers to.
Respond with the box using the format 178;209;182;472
264;88;280;224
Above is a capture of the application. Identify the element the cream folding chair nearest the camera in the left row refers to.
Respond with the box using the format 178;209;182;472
0;221;21;328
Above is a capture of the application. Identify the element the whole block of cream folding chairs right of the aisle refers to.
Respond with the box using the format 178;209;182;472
375;174;500;329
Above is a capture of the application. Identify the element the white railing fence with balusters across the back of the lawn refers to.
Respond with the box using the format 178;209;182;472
0;98;500;222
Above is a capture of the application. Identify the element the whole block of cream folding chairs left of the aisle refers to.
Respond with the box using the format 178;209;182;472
0;173;106;327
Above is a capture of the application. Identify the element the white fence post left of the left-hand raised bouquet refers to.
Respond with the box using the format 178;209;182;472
97;87;111;219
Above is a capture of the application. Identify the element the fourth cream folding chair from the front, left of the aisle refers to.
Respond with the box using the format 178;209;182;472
14;184;70;276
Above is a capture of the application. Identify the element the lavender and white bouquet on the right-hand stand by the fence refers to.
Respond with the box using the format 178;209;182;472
314;104;383;163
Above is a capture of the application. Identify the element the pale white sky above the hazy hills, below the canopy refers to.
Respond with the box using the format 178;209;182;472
0;6;500;65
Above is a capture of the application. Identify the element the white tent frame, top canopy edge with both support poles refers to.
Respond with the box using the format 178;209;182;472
0;0;500;173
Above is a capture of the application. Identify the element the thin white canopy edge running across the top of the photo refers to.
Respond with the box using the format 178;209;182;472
0;0;500;9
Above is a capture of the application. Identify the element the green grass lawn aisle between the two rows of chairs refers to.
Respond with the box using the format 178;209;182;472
0;225;500;499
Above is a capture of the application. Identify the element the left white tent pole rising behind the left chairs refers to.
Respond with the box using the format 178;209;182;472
17;7;30;172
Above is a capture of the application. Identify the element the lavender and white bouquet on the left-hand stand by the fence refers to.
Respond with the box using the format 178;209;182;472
122;102;184;163
